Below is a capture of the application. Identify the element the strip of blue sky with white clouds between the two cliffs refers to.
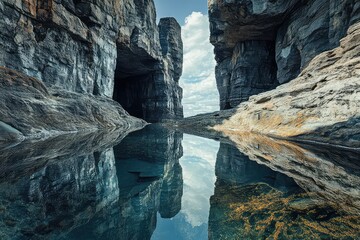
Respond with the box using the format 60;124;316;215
155;0;219;117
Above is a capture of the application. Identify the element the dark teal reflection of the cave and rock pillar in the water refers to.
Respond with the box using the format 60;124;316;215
68;125;183;239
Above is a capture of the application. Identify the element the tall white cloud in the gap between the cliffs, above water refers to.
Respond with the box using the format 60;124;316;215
180;12;219;117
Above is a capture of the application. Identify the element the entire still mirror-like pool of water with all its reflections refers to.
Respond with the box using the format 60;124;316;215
0;125;360;240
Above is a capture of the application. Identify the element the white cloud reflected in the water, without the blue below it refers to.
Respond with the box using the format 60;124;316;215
180;135;219;227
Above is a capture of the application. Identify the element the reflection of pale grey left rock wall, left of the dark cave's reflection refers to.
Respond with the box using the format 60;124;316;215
0;132;126;239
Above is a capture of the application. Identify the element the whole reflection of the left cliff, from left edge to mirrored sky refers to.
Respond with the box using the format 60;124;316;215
0;126;183;239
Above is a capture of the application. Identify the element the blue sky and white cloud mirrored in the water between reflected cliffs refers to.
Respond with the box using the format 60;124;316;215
151;135;219;240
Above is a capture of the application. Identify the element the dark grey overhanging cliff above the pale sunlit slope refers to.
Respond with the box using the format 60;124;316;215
209;0;360;109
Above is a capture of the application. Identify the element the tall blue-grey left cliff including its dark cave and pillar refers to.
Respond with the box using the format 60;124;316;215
0;0;182;121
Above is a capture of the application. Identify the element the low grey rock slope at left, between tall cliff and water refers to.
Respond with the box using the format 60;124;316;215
0;67;145;141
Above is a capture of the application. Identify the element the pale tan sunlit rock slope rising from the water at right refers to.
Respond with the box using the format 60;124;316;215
215;23;360;148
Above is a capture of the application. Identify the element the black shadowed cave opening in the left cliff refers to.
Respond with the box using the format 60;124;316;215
113;47;157;121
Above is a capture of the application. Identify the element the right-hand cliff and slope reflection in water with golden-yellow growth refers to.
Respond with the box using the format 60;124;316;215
209;135;360;239
